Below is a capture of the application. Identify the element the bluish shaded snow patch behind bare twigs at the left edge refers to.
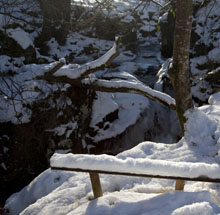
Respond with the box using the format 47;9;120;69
0;61;57;124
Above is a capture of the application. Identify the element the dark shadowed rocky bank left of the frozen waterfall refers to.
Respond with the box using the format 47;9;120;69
0;87;95;204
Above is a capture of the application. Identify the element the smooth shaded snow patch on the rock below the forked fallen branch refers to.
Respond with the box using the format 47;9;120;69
90;85;149;142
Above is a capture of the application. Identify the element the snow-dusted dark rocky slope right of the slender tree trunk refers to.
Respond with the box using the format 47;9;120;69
190;0;220;105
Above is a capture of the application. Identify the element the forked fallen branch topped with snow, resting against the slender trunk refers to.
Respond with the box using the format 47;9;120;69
40;35;176;109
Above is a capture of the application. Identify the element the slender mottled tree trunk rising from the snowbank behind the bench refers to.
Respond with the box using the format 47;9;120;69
169;0;193;135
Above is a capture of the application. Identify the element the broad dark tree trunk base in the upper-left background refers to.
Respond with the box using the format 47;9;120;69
40;0;71;45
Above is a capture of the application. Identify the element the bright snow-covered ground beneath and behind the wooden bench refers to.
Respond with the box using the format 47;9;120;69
6;93;220;215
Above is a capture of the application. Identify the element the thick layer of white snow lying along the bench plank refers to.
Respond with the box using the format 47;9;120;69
50;153;220;178
